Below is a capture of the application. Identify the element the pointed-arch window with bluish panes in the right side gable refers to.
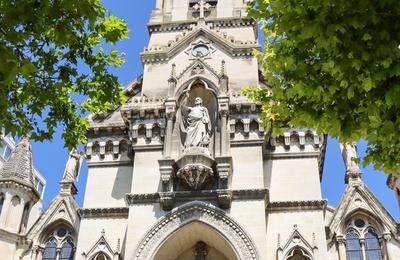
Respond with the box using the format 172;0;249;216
346;218;382;260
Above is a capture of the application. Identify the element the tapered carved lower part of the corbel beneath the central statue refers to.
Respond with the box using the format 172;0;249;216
176;164;213;190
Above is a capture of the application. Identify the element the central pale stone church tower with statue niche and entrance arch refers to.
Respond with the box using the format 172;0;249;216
78;0;326;259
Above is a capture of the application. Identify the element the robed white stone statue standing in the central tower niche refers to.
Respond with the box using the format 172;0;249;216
181;97;211;149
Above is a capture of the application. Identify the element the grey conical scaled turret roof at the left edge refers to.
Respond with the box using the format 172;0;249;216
0;137;34;185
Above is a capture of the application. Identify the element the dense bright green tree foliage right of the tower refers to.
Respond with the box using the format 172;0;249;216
246;0;400;173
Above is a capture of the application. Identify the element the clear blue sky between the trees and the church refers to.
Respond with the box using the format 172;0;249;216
29;0;400;221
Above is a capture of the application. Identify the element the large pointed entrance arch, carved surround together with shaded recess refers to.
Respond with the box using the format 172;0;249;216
134;201;258;260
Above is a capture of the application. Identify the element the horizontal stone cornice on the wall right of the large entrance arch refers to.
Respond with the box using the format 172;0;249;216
267;200;328;211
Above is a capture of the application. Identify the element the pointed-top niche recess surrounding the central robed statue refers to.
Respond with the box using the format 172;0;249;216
174;77;219;155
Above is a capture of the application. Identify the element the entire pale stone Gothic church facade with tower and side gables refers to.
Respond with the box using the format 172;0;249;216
0;0;400;260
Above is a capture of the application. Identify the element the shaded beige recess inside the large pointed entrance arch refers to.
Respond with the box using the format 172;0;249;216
153;221;234;260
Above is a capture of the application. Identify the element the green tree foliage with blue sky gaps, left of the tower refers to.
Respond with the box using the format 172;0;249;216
0;0;128;149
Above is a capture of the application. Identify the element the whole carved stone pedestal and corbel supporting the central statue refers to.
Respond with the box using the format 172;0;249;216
176;147;215;190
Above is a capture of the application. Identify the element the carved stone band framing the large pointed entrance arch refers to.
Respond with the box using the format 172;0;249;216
131;201;259;260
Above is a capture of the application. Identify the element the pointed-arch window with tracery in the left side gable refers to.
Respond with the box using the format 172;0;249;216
42;227;74;260
